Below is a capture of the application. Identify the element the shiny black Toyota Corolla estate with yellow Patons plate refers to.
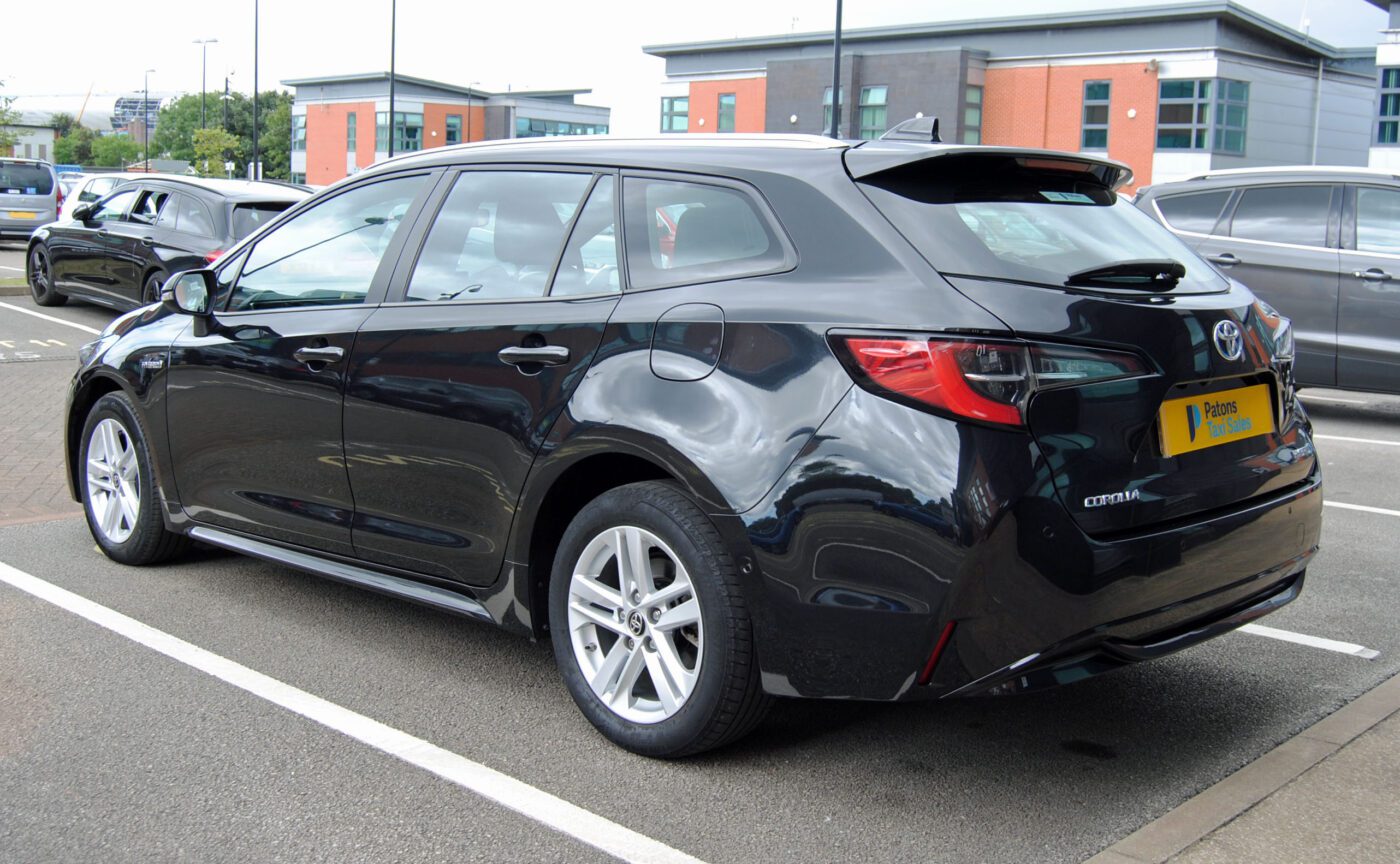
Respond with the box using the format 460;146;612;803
67;129;1322;756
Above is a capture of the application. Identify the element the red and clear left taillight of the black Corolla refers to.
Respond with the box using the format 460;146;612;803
841;336;1147;426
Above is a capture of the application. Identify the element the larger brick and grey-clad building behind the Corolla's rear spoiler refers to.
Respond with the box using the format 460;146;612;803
644;0;1400;188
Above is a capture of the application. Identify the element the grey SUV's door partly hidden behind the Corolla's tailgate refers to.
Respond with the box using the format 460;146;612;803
1196;183;1341;386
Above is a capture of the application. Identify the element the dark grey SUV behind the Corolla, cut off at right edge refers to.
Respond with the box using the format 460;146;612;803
1135;167;1400;393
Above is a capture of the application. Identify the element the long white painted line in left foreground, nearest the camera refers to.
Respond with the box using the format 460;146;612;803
0;562;701;864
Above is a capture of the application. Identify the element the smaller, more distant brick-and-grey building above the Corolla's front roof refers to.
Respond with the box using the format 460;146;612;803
283;71;610;185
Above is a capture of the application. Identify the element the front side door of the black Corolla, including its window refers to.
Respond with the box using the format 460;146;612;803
167;174;428;555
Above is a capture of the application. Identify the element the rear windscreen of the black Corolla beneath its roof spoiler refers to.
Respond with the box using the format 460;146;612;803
860;154;1228;293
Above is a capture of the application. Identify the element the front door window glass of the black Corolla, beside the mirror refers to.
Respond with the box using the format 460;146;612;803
228;175;424;311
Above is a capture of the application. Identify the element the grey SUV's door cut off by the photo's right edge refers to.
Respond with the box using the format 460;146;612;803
1337;186;1400;392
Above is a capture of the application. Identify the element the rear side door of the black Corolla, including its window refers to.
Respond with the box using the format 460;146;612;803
344;168;620;585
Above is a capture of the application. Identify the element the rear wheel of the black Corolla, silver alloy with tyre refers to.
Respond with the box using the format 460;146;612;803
550;483;769;758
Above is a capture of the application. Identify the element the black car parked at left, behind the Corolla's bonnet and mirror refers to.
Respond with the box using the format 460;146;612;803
25;175;309;309
